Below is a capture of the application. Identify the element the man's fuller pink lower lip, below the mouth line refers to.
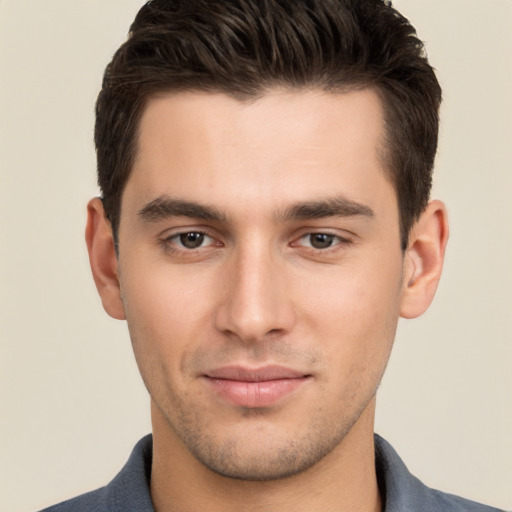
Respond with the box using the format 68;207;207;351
207;377;309;408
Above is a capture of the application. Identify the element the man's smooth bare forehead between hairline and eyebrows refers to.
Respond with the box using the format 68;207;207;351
123;89;396;220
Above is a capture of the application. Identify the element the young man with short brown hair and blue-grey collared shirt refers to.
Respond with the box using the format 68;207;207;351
40;0;504;512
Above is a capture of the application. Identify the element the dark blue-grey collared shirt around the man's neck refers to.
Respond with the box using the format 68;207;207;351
41;435;504;512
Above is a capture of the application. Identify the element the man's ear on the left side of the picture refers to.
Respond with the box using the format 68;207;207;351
85;197;125;320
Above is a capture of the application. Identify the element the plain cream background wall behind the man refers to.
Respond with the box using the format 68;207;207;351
0;0;512;512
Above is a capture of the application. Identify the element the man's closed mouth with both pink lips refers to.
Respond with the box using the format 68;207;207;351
203;366;312;408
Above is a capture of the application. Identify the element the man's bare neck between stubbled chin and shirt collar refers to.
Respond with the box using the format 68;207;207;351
151;399;382;512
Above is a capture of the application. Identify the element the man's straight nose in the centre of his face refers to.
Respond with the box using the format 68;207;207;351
215;247;295;342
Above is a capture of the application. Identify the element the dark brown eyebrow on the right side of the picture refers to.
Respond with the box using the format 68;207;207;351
279;197;375;220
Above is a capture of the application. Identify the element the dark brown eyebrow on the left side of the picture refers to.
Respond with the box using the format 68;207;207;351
138;196;227;222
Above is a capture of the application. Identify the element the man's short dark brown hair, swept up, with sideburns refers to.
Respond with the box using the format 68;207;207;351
95;0;441;249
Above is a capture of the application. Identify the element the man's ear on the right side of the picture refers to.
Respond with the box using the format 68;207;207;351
400;201;448;318
